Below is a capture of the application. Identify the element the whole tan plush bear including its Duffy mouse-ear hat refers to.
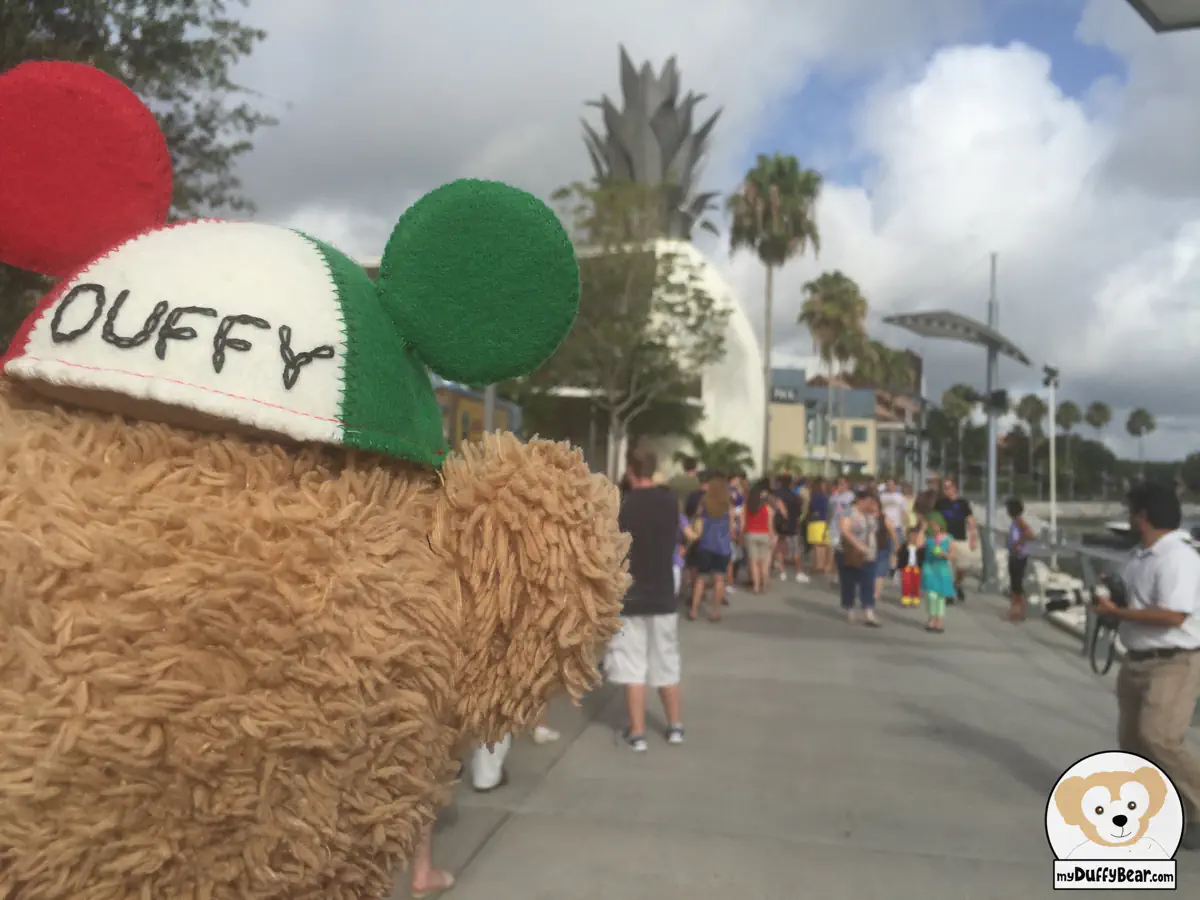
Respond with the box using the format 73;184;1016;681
0;62;628;900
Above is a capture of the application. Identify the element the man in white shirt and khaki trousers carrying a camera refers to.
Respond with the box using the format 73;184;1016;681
1097;482;1200;850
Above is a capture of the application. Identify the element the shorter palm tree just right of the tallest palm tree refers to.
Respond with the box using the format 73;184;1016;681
797;271;866;474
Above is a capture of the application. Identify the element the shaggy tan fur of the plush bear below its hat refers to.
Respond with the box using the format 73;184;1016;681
0;384;628;900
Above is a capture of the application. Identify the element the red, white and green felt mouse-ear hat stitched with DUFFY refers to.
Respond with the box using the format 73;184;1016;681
0;62;580;466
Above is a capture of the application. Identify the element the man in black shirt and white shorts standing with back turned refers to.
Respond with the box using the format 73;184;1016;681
605;448;683;752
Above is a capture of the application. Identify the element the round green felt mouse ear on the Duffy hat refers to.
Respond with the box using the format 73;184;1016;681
378;180;580;385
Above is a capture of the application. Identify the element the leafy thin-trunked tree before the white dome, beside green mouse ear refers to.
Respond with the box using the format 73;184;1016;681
547;181;732;478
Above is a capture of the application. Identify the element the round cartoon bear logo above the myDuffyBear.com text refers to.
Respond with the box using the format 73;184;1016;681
1046;752;1183;860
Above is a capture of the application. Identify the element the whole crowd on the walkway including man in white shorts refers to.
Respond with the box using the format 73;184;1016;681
604;446;1033;752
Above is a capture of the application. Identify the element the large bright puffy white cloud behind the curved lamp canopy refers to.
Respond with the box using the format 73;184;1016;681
732;28;1200;457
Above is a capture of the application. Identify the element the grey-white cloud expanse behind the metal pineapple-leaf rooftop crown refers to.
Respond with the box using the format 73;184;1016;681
239;0;979;247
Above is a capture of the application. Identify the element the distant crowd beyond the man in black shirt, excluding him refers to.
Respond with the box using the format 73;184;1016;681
622;450;1012;631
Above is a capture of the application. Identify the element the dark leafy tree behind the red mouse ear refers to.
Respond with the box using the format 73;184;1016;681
0;0;274;346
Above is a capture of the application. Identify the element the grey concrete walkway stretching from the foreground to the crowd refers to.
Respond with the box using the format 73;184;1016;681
395;583;1200;900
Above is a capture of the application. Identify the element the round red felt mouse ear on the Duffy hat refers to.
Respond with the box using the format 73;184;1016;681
0;62;172;277
